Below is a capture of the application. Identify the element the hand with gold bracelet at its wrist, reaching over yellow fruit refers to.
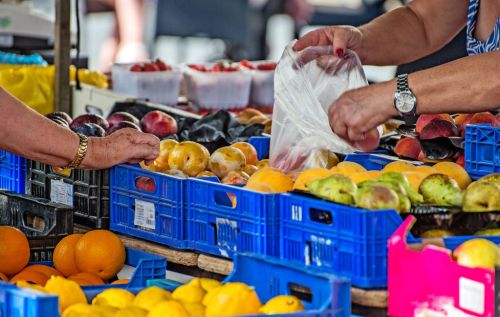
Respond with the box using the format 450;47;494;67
81;129;160;169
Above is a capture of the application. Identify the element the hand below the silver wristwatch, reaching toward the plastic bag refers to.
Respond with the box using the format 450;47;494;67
328;81;397;143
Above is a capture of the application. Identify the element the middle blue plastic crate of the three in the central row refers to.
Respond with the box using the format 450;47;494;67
186;178;279;257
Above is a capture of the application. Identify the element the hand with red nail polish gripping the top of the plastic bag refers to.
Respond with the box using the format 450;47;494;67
293;26;365;60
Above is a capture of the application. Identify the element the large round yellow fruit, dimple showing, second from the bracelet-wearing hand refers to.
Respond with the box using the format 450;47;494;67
168;141;210;177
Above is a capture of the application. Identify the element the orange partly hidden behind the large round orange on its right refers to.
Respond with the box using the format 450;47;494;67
52;233;83;276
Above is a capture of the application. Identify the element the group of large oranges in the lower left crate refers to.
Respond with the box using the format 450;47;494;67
0;226;128;292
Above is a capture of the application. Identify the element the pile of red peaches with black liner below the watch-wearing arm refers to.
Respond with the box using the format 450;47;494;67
394;112;500;166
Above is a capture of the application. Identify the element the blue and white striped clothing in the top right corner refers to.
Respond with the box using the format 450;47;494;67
467;0;500;55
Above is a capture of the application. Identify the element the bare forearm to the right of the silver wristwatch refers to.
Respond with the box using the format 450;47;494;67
409;52;500;113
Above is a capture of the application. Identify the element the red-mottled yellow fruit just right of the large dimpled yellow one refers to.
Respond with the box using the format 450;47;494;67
208;146;246;179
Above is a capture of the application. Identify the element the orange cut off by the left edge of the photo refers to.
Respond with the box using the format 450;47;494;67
0;226;30;275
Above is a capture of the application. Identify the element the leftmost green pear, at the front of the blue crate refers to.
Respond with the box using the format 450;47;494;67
307;174;357;205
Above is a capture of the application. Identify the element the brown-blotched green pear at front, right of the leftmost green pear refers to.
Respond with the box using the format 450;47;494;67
356;185;399;210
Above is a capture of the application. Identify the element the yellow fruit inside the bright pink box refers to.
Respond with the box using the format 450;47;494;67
453;238;500;270
